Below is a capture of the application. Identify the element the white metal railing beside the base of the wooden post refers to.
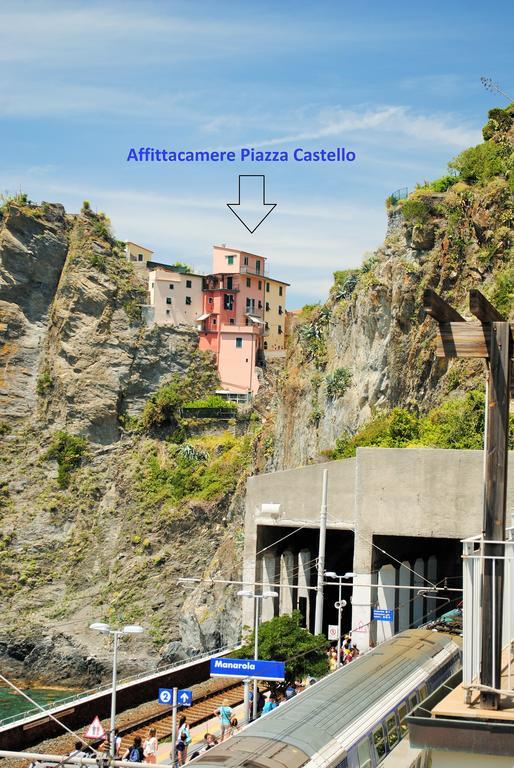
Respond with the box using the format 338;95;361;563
462;526;514;703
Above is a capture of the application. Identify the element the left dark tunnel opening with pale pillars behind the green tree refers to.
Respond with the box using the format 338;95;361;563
256;525;354;635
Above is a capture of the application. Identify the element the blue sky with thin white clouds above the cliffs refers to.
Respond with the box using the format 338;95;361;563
0;0;514;308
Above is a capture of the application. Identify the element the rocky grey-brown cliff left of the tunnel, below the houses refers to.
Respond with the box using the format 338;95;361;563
0;201;246;685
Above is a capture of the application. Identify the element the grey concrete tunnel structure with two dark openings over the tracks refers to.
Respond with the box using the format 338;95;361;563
243;448;514;650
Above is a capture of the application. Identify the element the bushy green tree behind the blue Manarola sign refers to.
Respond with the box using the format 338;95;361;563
237;611;328;680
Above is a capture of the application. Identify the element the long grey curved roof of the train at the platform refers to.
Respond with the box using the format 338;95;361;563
195;629;460;768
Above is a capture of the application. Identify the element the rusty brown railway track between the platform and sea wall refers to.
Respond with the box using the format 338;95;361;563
119;682;244;751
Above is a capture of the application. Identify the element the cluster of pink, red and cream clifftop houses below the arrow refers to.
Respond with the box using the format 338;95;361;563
142;244;288;395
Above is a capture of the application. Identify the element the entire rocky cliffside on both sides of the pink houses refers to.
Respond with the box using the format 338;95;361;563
0;108;514;685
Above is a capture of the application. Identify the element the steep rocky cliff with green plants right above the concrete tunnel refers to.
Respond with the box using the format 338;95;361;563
268;108;514;468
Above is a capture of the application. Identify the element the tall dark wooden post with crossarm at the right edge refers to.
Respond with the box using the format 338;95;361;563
423;289;514;709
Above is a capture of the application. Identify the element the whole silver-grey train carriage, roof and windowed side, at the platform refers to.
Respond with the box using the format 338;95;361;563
192;629;461;768
